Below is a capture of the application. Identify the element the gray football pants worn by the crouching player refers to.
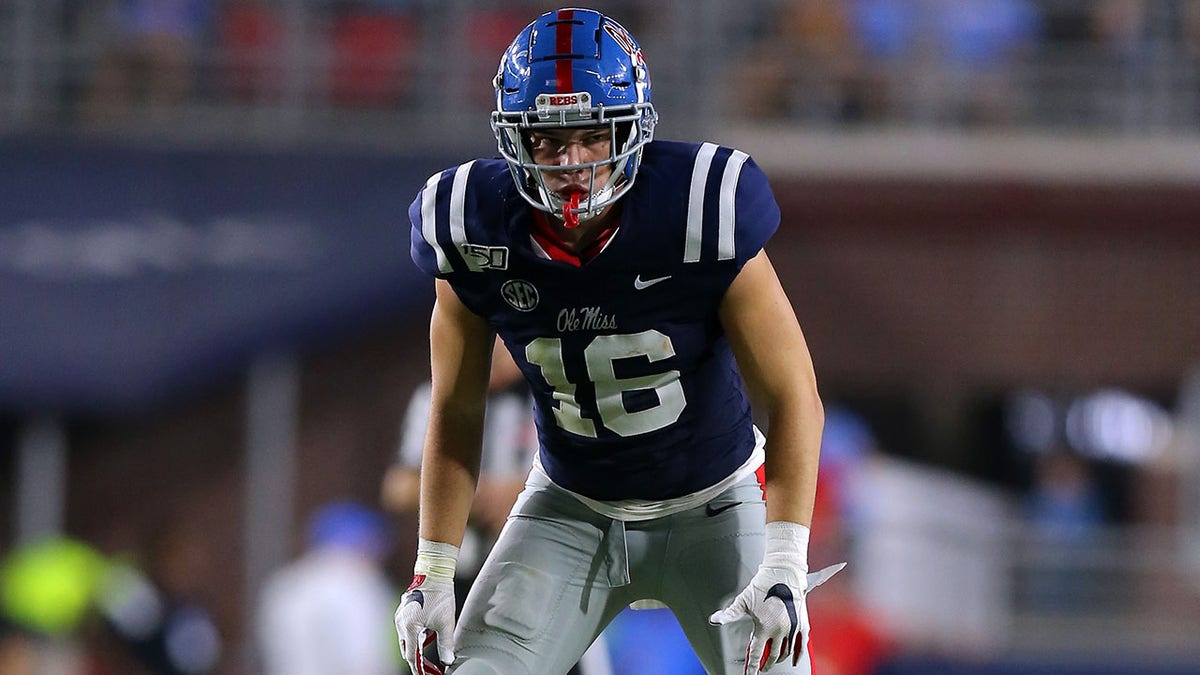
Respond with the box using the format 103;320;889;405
450;476;811;675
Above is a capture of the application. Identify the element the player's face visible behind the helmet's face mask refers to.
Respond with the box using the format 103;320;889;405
529;126;612;198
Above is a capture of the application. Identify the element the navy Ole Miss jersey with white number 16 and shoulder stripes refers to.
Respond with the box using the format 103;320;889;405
409;141;779;500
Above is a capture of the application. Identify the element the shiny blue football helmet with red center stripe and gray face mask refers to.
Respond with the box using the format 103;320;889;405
492;8;658;226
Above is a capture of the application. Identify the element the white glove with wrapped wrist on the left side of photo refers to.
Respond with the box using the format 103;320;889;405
395;539;458;675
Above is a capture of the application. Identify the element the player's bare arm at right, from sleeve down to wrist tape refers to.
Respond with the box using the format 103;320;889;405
720;251;824;526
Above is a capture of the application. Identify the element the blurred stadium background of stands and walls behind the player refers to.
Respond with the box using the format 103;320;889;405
0;0;1200;675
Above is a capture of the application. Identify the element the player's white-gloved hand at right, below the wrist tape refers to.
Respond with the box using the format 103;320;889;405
708;562;846;675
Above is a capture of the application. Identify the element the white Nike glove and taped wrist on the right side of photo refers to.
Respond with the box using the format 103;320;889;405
708;521;846;675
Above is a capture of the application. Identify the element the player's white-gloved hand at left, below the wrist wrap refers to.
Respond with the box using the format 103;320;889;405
396;574;455;675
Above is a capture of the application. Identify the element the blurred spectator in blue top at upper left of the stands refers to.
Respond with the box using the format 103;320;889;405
83;0;212;127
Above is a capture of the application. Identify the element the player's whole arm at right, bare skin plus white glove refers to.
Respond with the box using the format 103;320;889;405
709;251;840;675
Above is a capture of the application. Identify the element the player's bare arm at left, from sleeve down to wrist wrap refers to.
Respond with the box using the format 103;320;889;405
420;280;494;546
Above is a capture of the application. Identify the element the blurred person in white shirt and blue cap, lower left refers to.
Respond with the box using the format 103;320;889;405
258;502;400;675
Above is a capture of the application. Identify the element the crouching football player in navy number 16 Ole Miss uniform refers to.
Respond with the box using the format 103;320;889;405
396;10;836;675
